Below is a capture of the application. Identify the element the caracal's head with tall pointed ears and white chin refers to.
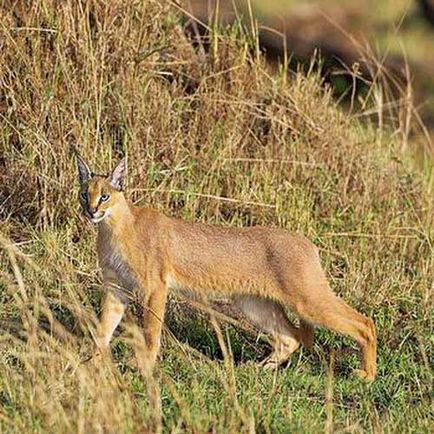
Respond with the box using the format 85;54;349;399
76;148;125;224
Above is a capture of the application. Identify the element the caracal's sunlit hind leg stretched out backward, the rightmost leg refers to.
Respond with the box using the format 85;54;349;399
295;285;377;381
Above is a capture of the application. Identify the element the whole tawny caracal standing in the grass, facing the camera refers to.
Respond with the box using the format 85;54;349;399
77;156;376;380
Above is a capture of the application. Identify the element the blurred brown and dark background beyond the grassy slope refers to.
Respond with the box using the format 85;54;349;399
184;0;434;143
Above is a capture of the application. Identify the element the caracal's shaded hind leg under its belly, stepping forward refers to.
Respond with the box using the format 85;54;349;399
235;296;302;367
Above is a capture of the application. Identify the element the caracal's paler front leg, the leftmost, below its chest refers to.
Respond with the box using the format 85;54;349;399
95;282;126;355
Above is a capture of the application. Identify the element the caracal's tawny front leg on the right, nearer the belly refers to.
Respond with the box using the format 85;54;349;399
143;280;168;370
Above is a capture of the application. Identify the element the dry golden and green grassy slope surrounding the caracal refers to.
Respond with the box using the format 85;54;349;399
0;1;434;432
